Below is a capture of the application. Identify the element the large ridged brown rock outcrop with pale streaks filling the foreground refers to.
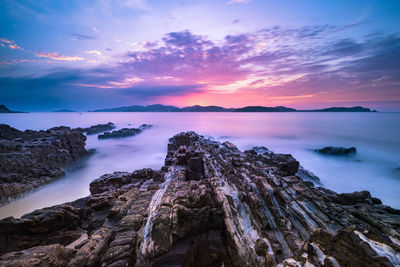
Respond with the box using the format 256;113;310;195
0;132;400;267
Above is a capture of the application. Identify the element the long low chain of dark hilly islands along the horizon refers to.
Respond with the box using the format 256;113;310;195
91;104;376;112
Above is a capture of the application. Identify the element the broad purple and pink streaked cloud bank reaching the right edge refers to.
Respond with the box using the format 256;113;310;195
121;28;400;109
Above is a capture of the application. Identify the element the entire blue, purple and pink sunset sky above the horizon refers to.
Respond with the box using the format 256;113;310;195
0;0;400;111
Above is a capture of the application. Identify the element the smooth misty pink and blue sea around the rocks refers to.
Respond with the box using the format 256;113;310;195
0;112;400;218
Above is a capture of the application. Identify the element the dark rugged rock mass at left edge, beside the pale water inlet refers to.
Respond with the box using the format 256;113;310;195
0;124;87;204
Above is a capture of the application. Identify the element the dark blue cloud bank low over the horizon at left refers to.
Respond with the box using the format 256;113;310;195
0;68;205;111
